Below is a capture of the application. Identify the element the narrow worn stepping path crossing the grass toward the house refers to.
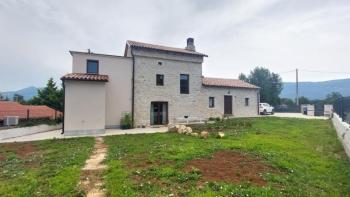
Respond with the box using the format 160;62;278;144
80;137;107;197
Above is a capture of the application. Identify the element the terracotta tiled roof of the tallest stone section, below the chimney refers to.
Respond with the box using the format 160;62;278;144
126;40;208;57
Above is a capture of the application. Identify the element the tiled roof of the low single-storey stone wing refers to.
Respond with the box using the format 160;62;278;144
202;77;259;89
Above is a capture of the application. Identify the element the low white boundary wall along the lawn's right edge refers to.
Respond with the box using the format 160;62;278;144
332;113;350;158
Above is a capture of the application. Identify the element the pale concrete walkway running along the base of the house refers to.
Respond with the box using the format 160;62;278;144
0;127;168;143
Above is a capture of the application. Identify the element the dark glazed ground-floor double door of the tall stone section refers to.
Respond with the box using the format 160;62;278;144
151;102;168;125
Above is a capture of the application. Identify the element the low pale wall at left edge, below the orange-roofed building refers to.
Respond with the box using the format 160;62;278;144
0;124;62;140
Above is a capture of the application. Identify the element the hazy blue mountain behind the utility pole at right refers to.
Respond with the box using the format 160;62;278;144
280;79;350;99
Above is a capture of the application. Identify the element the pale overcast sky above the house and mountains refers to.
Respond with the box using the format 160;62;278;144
0;0;350;91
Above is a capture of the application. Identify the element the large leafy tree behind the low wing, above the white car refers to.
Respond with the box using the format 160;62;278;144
239;67;283;105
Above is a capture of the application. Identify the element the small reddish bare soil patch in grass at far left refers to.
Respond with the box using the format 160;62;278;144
3;142;38;159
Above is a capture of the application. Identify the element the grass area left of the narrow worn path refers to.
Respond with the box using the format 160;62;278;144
0;138;94;196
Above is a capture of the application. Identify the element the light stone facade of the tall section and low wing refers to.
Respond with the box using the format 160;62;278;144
134;48;258;126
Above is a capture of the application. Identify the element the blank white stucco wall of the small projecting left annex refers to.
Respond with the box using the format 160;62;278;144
64;80;106;135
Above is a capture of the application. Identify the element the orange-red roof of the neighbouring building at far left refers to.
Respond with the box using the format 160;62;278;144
0;101;62;120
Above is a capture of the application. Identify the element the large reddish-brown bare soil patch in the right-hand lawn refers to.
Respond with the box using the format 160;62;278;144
185;151;276;186
